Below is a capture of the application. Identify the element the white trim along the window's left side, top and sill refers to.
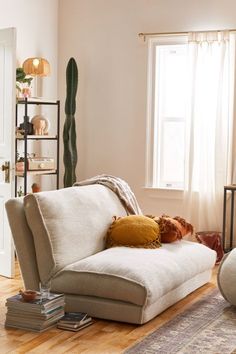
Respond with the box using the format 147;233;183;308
145;34;188;192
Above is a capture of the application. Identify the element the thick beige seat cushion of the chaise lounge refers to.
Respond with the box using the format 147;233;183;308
52;240;216;306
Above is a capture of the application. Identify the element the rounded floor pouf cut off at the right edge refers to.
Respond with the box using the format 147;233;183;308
217;248;236;306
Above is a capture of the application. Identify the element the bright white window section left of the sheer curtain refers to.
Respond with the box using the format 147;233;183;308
147;36;188;189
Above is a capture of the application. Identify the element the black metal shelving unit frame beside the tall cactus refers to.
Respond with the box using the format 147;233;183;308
15;98;60;196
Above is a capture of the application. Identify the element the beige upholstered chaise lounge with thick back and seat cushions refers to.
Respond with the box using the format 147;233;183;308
6;185;216;324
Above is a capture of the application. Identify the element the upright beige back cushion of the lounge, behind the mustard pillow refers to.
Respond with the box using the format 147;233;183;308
24;185;126;281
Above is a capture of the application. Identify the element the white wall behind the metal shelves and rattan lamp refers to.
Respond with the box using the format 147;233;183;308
0;0;58;194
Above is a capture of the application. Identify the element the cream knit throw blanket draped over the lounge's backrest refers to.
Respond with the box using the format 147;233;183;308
74;174;142;215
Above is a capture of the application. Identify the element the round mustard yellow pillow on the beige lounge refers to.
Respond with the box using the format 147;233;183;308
106;215;161;248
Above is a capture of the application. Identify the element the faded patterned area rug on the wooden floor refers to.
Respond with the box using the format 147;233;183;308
125;289;236;354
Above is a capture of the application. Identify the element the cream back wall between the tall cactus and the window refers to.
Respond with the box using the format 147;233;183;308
59;0;236;215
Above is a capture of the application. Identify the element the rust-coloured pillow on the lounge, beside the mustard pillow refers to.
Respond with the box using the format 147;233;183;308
149;215;193;243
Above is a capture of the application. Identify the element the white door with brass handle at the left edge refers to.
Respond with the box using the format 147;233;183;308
0;28;16;277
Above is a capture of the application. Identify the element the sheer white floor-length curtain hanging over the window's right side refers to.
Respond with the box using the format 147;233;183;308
184;31;235;231
